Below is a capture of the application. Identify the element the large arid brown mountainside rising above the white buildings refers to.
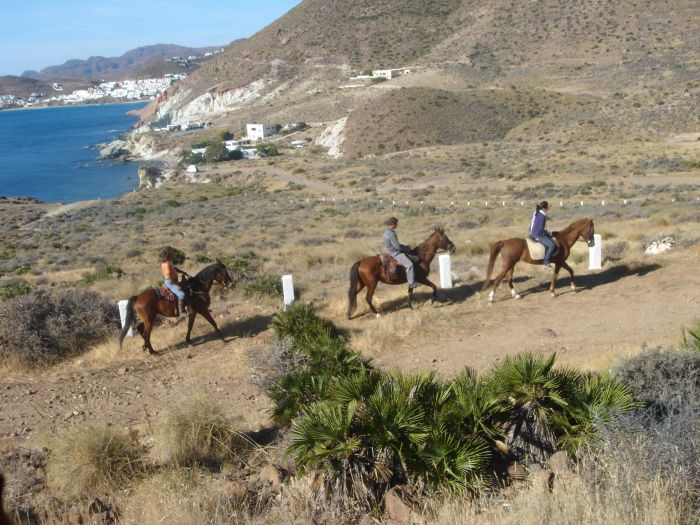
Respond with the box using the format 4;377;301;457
135;0;700;156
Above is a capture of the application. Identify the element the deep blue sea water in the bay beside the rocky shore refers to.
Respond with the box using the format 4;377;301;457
0;102;145;202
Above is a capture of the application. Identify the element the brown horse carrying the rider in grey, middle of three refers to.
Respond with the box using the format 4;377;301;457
348;226;455;319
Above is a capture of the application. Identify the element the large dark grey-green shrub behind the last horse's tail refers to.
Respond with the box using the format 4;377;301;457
0;289;119;365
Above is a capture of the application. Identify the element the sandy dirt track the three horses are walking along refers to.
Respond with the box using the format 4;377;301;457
0;250;700;445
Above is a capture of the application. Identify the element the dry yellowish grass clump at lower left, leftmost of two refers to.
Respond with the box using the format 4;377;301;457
47;426;145;497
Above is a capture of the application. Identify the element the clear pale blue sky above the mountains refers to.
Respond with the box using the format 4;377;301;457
0;0;301;75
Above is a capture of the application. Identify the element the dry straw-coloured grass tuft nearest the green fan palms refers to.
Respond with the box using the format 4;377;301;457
161;395;250;466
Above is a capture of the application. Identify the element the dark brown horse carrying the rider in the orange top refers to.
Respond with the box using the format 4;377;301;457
119;259;233;355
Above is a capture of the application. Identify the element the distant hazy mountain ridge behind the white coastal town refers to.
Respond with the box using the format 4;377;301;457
22;44;219;81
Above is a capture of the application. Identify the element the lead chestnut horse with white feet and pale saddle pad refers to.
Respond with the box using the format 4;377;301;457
481;215;595;302
